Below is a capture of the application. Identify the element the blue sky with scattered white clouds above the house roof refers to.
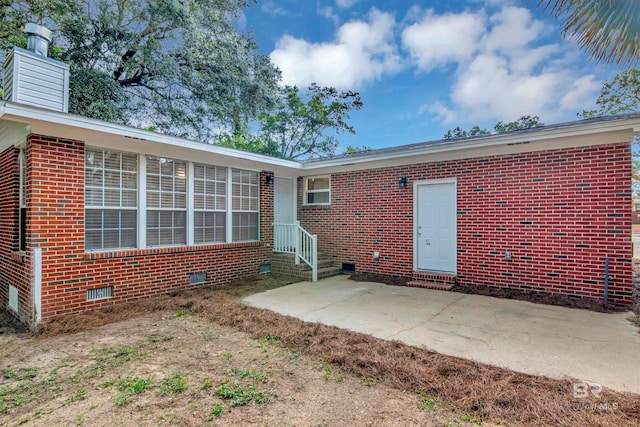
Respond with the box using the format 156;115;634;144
241;0;622;150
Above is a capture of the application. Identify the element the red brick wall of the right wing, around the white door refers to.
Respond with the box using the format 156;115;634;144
298;144;632;304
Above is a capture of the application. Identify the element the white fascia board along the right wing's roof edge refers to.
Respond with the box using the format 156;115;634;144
302;118;640;172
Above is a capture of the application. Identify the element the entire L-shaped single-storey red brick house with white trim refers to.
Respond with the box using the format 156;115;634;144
0;39;640;326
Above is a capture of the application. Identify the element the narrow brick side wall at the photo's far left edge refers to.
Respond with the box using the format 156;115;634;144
0;147;32;322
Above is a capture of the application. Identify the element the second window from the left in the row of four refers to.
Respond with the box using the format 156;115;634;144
146;156;187;246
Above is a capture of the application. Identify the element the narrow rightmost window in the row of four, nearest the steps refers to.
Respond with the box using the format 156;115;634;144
231;169;259;242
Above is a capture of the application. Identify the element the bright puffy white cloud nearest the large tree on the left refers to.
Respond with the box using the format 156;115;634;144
271;9;401;89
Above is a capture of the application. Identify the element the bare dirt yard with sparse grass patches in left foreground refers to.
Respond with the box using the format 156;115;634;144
0;276;468;426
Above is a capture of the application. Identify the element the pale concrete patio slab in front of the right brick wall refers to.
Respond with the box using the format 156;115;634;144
244;276;640;393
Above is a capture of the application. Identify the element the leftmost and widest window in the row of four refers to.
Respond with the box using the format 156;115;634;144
85;148;138;250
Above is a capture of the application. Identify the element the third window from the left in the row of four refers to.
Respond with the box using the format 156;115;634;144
193;163;227;244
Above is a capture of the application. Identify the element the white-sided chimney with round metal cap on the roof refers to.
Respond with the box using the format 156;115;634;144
3;24;69;113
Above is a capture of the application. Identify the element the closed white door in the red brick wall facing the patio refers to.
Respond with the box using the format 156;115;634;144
414;182;457;273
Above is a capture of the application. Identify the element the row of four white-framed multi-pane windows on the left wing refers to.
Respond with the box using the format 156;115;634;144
85;148;260;251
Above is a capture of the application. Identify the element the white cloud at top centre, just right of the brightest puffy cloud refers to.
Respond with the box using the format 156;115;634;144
402;10;486;72
